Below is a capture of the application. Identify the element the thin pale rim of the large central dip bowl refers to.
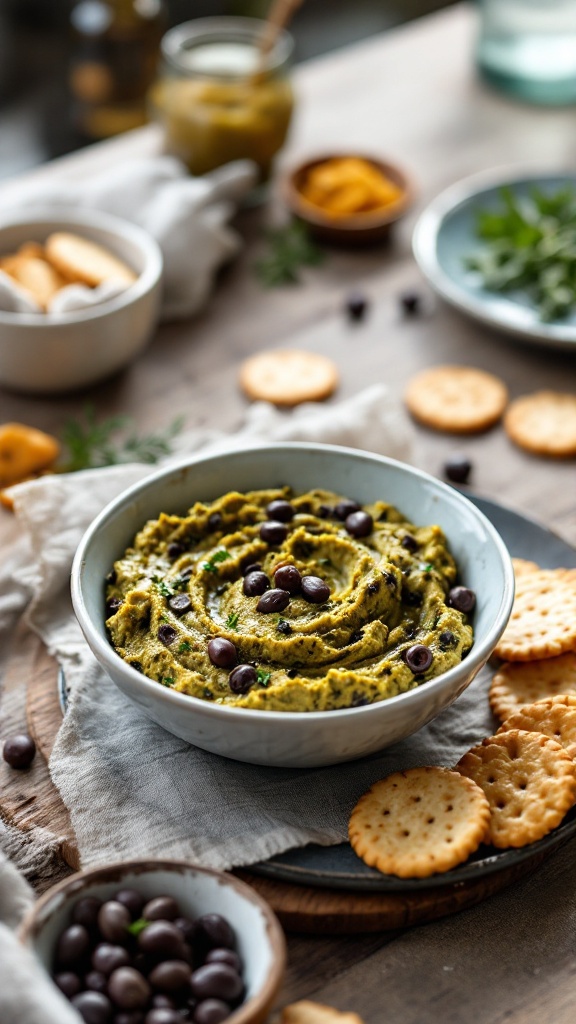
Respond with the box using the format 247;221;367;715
71;441;515;724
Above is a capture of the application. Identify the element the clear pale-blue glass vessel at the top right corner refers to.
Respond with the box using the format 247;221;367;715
477;0;576;104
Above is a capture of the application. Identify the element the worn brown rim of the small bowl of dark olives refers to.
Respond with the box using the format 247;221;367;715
17;857;287;1024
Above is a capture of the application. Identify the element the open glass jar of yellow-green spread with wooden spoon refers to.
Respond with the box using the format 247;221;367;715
150;17;293;181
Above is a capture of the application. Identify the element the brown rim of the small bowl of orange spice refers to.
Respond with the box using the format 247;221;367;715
280;150;416;232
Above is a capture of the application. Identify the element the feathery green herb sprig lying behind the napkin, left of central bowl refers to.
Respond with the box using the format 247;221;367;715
60;406;183;473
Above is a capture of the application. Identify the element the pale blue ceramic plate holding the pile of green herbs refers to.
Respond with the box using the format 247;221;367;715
412;173;576;353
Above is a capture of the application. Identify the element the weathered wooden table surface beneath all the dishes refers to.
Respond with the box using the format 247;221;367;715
0;5;576;1024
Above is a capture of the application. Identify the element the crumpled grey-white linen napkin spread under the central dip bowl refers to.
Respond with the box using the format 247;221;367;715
1;386;498;868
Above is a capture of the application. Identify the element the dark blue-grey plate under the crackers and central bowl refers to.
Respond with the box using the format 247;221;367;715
250;495;576;893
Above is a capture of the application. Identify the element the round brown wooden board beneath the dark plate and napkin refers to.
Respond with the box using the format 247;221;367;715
0;633;545;935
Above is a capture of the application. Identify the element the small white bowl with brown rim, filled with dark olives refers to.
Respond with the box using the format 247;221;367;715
20;860;286;1024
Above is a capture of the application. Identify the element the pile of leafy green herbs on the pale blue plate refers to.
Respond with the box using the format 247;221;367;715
464;184;576;322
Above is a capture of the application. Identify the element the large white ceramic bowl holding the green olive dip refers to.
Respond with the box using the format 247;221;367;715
72;443;513;768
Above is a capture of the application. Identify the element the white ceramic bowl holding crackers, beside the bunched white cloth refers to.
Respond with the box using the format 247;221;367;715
0;208;162;394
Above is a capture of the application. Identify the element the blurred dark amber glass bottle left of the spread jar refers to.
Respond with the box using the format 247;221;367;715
69;0;166;139
